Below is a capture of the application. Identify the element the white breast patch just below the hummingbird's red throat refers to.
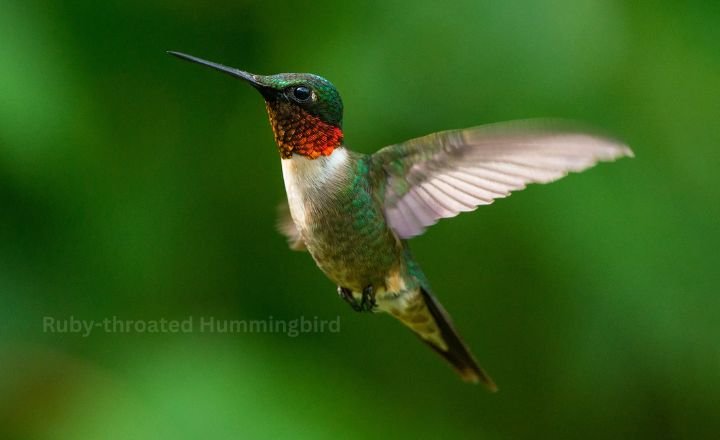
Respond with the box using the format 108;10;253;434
281;148;349;231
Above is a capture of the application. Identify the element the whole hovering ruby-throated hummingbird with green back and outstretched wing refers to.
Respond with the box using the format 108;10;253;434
168;51;633;391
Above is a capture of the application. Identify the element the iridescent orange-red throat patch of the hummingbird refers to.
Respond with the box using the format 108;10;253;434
265;101;343;159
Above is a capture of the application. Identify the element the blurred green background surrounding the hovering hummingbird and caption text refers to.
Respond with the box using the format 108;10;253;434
0;0;720;439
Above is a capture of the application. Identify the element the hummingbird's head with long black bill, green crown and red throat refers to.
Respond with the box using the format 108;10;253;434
168;52;343;159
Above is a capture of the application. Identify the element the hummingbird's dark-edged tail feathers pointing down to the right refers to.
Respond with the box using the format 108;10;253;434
394;288;497;392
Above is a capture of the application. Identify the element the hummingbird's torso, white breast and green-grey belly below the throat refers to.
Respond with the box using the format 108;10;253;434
283;150;402;292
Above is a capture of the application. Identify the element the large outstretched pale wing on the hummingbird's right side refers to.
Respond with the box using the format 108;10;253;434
373;120;633;238
